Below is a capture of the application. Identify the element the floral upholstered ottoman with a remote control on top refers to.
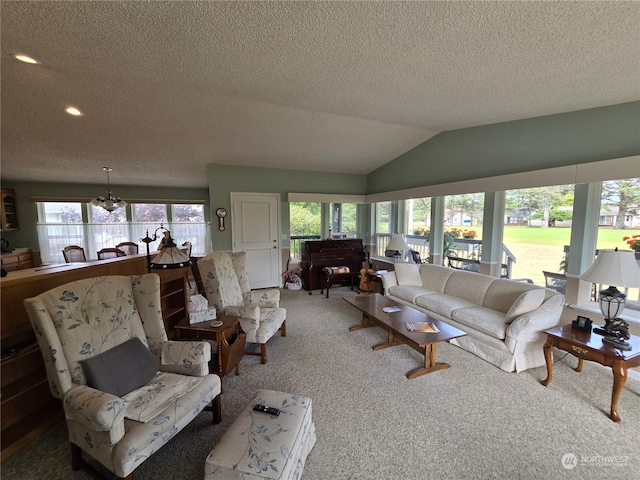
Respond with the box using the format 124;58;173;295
204;390;316;480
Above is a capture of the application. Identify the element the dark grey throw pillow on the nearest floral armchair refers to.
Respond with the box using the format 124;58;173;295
80;337;158;397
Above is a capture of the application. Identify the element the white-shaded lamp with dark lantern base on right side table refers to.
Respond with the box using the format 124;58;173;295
580;248;640;349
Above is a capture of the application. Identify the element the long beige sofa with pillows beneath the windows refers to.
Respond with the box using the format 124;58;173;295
382;264;564;372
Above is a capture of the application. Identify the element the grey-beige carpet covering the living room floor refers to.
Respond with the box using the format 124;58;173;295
0;288;640;480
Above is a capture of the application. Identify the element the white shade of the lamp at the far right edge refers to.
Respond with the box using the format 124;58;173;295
580;249;640;288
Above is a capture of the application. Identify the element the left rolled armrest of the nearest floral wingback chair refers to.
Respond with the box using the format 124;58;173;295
63;385;125;434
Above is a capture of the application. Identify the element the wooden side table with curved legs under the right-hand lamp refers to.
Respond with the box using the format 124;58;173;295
542;324;640;422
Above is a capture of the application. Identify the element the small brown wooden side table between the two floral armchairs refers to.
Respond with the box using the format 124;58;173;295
176;315;247;390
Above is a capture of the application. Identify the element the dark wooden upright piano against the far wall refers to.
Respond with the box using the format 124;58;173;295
300;238;366;294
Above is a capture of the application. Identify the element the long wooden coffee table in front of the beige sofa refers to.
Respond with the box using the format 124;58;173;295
343;293;466;378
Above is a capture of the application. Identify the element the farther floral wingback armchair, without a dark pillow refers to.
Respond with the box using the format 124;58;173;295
198;252;287;363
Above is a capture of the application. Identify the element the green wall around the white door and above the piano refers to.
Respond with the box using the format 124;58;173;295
208;164;367;250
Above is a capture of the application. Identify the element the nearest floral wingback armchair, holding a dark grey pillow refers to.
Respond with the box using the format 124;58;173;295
24;273;221;478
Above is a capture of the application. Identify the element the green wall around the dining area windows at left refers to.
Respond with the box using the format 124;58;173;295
2;181;209;250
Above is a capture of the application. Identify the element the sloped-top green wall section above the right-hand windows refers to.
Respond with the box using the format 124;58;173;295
367;102;640;195
